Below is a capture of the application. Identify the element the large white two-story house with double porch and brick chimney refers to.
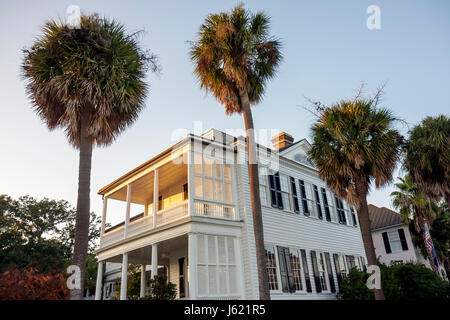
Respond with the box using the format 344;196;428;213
96;129;366;299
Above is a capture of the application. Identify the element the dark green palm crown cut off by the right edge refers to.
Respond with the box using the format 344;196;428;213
405;115;450;207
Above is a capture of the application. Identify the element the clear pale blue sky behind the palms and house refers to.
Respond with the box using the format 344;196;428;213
0;0;450;225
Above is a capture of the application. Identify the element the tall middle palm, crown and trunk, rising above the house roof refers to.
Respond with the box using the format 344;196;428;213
190;5;281;299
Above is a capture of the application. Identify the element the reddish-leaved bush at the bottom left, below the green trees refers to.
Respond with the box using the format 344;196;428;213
0;268;69;300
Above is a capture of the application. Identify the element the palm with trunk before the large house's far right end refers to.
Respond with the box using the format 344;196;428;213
309;94;401;300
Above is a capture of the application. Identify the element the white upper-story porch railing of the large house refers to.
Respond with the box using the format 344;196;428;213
101;199;236;247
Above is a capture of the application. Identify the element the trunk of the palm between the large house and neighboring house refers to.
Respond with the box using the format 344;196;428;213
356;182;385;300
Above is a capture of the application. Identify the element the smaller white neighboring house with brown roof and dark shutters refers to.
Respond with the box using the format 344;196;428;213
369;204;446;279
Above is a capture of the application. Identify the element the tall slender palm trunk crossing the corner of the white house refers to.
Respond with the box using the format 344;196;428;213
240;92;270;300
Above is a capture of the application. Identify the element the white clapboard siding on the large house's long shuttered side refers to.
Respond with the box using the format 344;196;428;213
236;142;367;299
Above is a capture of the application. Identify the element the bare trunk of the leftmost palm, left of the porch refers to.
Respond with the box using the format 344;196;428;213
70;117;92;300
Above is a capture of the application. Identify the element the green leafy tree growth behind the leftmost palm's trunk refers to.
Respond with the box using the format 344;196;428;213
0;195;101;292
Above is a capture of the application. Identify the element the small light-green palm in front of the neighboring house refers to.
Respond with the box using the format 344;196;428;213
391;174;439;275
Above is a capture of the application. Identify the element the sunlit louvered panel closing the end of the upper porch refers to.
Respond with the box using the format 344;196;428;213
194;153;232;202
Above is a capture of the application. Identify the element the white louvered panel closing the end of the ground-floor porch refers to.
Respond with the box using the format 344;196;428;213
197;234;238;296
